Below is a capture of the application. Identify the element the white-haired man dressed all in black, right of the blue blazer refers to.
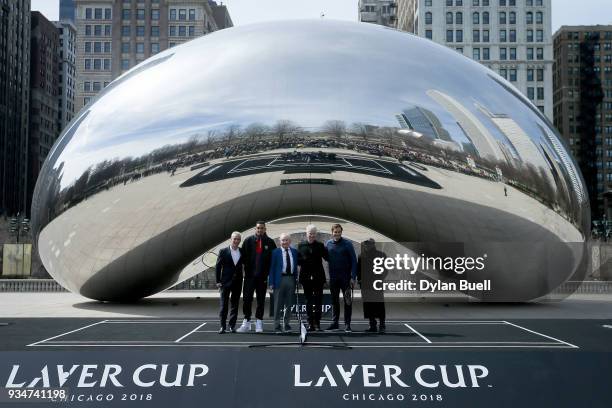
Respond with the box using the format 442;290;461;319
298;224;329;331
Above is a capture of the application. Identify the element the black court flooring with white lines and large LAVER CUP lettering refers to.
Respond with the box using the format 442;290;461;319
0;317;612;408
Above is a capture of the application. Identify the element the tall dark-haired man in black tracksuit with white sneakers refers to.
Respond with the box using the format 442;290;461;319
238;221;276;333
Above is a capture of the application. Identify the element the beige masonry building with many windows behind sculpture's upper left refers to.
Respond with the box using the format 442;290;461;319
74;0;231;112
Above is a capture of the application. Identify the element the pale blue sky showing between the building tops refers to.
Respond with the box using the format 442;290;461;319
32;0;612;33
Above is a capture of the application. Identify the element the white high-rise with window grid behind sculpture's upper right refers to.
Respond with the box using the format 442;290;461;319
397;0;553;120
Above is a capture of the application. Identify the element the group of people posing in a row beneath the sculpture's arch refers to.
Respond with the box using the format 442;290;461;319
216;221;385;334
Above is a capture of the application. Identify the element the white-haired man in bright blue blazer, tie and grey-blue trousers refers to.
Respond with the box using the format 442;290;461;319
269;233;298;333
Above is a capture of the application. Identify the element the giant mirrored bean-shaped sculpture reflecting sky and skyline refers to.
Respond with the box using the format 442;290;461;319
32;20;590;301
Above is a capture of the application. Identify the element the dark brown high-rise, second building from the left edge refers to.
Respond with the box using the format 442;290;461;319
27;11;60;212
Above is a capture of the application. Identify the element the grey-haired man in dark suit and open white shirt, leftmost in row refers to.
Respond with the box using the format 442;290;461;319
215;232;244;334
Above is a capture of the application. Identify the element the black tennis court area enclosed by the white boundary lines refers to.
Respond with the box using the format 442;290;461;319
21;319;579;349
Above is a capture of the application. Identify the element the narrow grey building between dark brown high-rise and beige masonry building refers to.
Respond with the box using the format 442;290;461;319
55;20;76;132
